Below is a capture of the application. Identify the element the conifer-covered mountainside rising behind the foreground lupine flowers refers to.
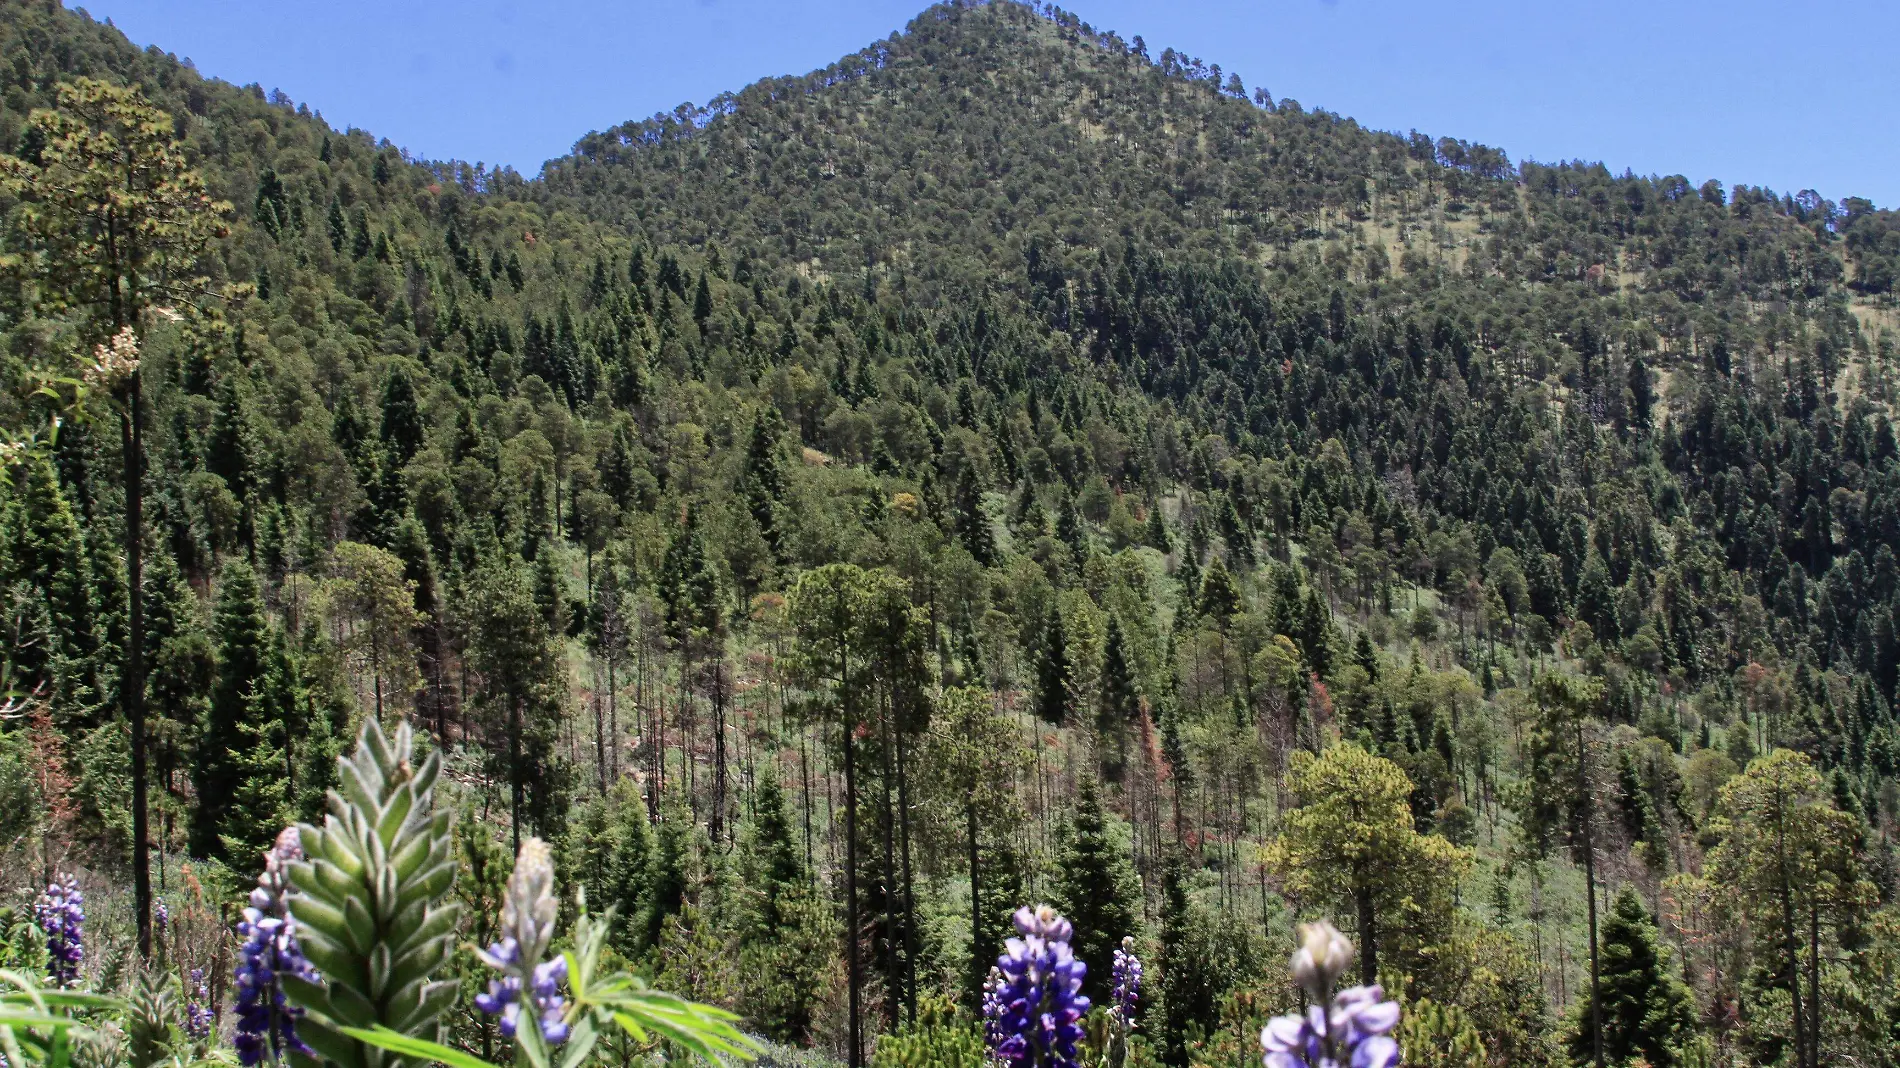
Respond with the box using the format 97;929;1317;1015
0;0;1900;1068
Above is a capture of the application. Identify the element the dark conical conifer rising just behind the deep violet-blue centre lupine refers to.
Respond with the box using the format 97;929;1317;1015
1051;775;1142;1005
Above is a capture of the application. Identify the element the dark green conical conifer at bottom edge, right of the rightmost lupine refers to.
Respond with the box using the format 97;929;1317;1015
1566;886;1695;1068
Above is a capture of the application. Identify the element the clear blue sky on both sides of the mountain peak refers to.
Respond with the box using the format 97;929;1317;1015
87;0;1900;205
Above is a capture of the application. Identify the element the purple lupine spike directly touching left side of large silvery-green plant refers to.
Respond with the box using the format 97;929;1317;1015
232;827;321;1066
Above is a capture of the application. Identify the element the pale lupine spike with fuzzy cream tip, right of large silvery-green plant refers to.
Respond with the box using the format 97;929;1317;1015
475;838;568;1045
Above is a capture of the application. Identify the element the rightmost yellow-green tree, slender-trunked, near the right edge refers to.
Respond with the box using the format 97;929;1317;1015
1708;749;1875;1068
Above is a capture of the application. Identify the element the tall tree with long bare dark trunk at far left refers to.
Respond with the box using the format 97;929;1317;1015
0;78;230;954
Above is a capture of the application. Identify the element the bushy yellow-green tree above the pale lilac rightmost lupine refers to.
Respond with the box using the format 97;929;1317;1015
1267;743;1473;982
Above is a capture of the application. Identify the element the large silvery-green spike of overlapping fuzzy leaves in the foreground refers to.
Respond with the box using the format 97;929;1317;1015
276;720;460;1068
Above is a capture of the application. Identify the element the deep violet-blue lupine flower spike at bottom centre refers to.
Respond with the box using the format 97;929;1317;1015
990;905;1089;1068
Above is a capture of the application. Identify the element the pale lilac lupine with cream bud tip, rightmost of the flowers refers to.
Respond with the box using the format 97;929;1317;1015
1260;922;1398;1068
